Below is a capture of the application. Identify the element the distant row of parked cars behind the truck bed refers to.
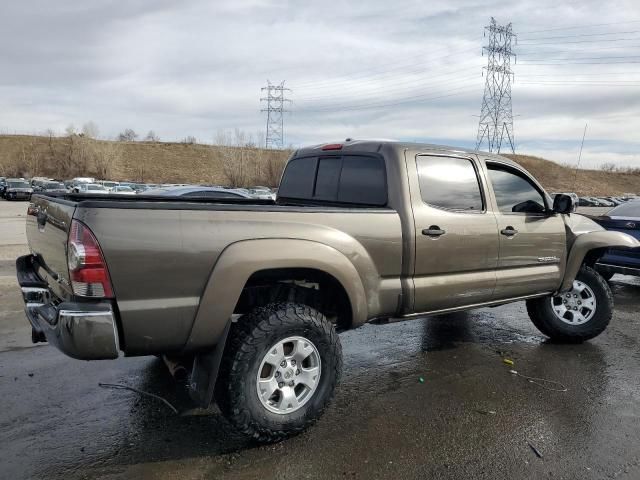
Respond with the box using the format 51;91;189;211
0;177;275;200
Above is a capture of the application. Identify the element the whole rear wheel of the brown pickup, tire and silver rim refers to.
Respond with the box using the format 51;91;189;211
216;303;342;442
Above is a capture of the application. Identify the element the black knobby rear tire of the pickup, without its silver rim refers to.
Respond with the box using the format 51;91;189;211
215;303;342;442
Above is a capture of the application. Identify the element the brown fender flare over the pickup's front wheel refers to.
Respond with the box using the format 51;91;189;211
559;230;640;292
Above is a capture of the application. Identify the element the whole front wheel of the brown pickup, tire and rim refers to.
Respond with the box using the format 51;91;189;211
527;265;613;342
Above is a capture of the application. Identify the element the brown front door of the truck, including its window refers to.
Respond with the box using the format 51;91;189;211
486;160;566;300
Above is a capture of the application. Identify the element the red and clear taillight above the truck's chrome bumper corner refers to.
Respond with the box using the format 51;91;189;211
67;220;113;298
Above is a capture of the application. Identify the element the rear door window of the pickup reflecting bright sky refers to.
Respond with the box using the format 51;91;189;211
416;155;484;212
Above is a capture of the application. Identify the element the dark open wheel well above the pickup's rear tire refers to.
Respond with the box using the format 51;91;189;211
233;268;353;330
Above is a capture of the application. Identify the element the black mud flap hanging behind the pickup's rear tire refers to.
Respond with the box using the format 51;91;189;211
189;320;232;408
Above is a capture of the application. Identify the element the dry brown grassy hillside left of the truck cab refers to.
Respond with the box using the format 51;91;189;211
0;135;290;186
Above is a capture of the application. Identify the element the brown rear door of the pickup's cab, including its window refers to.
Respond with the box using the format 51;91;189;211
406;154;499;313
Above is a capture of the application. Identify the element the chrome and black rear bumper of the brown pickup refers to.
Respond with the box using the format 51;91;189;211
16;255;119;360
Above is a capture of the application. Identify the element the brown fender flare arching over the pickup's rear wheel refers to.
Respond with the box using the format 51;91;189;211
184;239;368;350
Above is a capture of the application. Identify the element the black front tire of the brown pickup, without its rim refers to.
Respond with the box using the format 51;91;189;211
527;265;613;343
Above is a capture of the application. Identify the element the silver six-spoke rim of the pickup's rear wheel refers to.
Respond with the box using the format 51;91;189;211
256;337;321;415
